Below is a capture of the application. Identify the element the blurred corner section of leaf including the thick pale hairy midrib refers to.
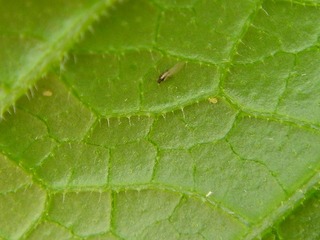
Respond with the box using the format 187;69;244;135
0;0;113;116
